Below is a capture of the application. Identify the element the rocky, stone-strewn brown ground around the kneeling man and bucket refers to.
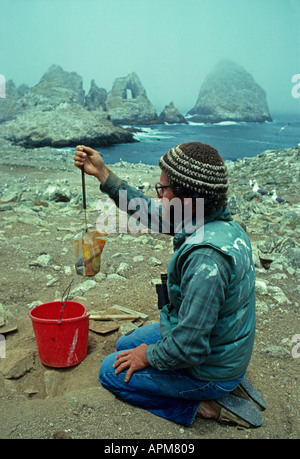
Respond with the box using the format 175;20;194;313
0;144;300;441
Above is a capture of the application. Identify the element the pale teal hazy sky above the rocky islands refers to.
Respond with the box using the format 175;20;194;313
0;0;300;115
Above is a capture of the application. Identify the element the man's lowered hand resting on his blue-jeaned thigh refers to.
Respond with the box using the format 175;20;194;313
113;344;149;382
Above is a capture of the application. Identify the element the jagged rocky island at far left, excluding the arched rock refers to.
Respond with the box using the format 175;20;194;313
0;65;135;148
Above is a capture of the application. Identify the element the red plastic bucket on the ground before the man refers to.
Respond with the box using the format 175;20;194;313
29;301;89;368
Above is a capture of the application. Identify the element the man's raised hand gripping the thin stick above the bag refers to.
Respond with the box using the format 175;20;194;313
73;145;110;184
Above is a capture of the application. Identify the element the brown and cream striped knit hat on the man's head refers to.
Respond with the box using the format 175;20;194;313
159;142;228;199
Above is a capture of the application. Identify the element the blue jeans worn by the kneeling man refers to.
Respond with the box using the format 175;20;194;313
99;323;244;427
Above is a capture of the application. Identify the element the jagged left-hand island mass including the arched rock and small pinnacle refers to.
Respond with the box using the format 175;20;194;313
0;65;190;148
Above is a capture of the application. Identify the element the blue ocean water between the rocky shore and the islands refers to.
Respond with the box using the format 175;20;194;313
98;117;300;165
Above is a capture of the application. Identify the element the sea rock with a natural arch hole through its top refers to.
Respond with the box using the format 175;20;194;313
106;72;158;124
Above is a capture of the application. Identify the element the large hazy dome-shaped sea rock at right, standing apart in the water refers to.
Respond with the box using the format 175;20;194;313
188;59;272;123
